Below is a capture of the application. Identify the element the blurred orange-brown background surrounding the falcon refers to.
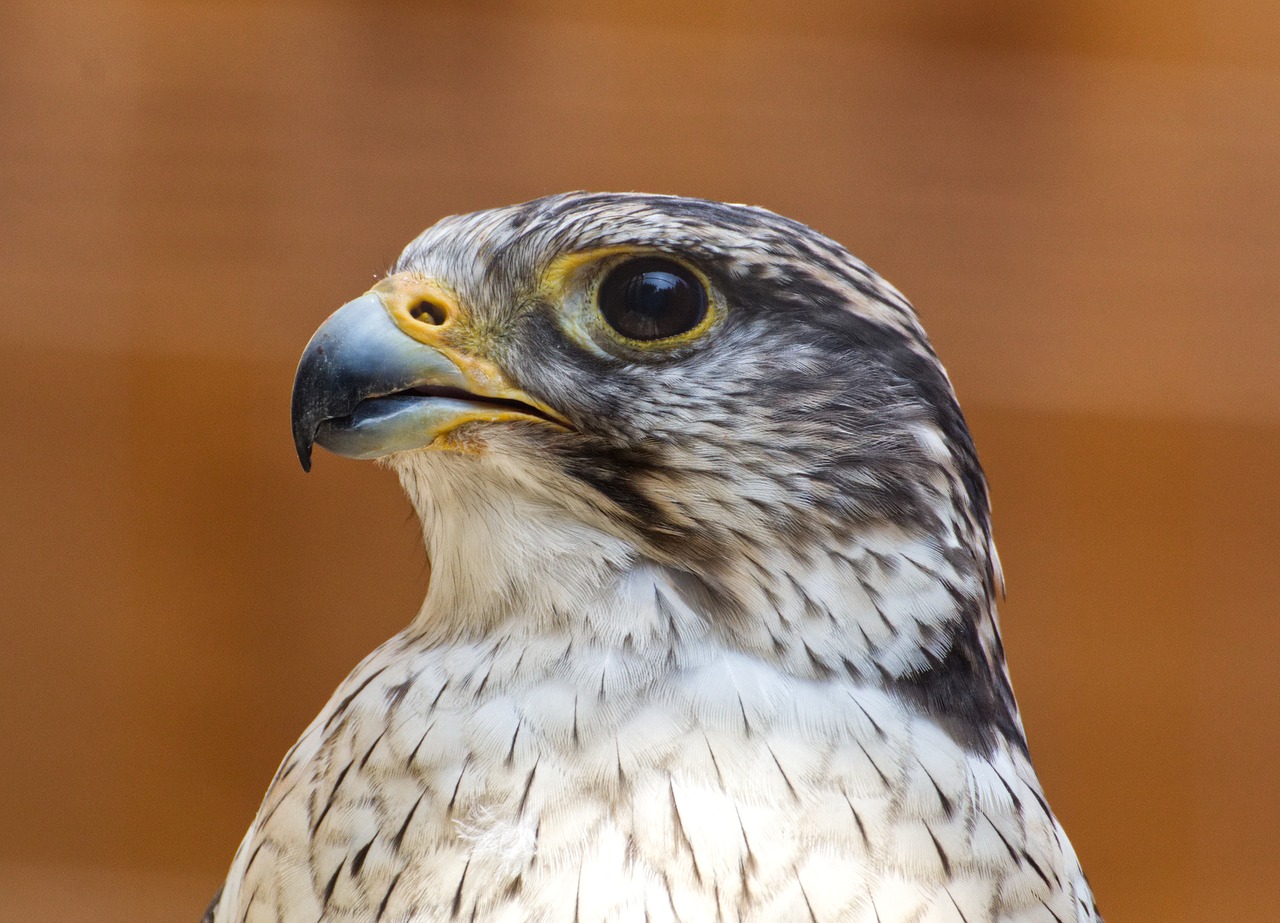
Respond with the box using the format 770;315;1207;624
0;0;1280;923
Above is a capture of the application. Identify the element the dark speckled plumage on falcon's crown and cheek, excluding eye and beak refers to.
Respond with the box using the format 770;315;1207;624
394;193;1021;746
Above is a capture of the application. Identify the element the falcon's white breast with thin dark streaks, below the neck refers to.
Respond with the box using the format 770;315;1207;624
224;567;1074;922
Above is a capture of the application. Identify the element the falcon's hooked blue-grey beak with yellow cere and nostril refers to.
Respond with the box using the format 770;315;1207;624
292;274;567;471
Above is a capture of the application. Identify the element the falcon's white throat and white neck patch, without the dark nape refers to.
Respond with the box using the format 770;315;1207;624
392;452;983;678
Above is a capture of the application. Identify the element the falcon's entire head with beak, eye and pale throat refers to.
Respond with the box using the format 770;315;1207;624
293;193;1016;757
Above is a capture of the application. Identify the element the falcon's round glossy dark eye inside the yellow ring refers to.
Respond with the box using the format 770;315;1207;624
596;257;707;341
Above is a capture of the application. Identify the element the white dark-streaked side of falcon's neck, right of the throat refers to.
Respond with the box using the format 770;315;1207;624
676;512;1025;751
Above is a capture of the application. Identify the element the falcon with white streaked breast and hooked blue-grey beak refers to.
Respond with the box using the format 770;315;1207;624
206;193;1100;923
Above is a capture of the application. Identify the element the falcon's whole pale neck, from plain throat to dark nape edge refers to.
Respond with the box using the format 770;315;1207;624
399;456;1025;750
